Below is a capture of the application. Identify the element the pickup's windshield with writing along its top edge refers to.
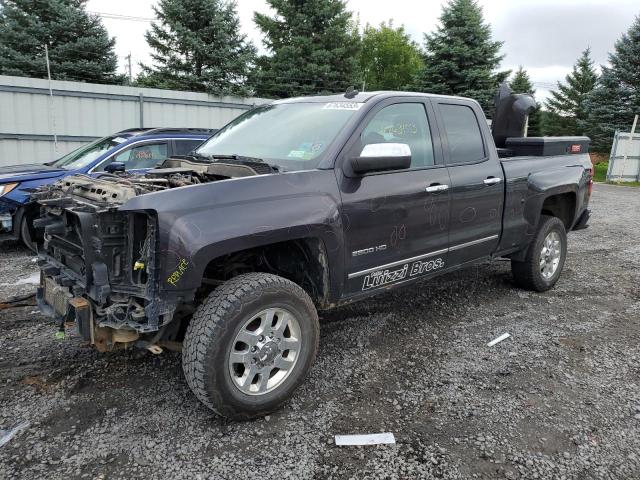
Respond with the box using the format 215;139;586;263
196;102;362;170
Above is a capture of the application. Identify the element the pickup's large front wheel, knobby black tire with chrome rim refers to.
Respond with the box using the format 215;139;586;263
182;273;320;420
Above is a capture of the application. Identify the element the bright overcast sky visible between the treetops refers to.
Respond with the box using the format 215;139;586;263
87;0;640;97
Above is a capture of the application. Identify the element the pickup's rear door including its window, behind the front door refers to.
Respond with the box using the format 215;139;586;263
435;99;504;265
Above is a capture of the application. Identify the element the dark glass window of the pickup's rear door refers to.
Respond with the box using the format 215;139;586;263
440;104;486;163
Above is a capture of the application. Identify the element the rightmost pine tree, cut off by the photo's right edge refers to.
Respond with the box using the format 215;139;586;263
579;16;640;153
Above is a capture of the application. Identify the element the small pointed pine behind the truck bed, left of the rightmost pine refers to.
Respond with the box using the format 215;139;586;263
545;48;598;135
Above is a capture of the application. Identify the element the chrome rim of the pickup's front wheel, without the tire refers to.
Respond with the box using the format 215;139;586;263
229;308;302;395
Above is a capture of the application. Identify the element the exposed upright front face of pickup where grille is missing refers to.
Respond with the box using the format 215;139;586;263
34;198;175;333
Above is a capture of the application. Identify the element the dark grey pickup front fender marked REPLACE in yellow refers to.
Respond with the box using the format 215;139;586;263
121;170;344;296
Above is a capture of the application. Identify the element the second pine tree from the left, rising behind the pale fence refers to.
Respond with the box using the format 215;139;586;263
137;0;256;96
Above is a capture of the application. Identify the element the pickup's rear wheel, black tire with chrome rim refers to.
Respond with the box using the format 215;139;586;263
511;215;567;292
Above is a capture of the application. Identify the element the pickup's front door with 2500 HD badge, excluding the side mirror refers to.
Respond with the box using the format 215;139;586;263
336;97;449;294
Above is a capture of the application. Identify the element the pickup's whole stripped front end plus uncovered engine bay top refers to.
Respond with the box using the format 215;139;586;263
32;158;276;351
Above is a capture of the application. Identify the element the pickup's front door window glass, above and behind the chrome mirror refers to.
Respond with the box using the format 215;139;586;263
360;103;434;168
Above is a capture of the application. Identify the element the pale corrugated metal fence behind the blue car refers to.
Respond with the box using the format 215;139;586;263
0;75;269;166
